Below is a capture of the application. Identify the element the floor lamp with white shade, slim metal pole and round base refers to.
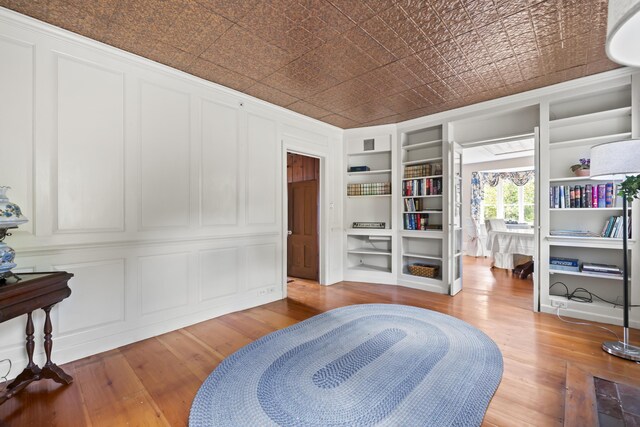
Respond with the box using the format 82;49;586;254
591;139;640;362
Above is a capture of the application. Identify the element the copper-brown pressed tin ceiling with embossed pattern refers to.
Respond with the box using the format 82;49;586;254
0;0;618;128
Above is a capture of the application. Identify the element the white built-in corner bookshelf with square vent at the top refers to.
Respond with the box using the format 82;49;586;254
345;134;393;280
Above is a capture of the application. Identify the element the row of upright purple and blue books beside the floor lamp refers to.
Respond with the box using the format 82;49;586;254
549;182;616;209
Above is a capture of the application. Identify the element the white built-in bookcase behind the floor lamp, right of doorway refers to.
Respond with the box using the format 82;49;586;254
536;77;640;327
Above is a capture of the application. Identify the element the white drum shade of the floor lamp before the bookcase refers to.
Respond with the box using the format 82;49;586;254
591;139;640;180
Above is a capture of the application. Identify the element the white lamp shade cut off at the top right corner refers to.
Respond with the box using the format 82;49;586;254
606;0;640;67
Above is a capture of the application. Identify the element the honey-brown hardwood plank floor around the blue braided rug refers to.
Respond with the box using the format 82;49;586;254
0;257;640;426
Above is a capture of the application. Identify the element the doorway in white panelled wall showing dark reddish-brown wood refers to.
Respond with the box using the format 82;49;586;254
287;152;320;281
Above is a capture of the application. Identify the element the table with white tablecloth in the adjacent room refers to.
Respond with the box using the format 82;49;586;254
487;230;535;269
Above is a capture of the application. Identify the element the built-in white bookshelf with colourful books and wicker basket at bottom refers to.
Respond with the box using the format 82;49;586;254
398;126;448;290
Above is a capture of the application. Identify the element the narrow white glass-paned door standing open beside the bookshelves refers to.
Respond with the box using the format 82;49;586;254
448;142;463;295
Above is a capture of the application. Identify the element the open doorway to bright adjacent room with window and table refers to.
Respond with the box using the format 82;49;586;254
462;133;537;295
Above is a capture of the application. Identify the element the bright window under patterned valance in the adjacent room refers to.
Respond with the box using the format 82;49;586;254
480;179;535;224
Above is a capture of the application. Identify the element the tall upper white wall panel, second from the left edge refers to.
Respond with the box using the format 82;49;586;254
54;52;125;233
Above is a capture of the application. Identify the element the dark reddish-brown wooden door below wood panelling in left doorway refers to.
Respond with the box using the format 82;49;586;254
287;179;318;280
